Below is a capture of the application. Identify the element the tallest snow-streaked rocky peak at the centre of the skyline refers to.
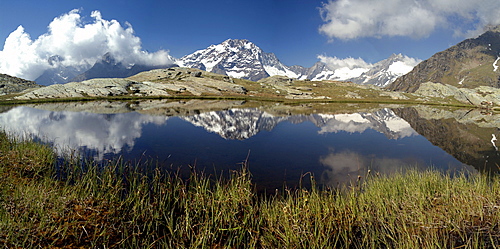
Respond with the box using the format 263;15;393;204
177;39;298;81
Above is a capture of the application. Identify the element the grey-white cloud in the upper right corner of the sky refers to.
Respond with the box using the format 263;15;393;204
319;0;500;40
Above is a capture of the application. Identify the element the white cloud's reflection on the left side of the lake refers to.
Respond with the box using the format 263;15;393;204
0;107;167;155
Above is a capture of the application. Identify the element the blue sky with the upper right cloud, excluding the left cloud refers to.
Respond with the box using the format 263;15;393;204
0;0;500;80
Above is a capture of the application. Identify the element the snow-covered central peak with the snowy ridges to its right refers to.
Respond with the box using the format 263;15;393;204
177;39;418;86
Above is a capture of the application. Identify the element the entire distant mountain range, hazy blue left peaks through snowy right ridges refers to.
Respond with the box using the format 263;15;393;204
35;39;417;87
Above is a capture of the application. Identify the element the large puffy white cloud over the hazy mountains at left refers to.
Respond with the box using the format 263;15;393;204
0;10;173;80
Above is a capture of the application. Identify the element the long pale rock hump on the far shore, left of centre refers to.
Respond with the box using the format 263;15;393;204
15;68;246;100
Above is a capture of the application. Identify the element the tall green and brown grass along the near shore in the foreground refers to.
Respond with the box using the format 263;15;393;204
0;132;500;248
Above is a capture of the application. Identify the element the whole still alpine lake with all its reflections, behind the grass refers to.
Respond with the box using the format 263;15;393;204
0;100;500;192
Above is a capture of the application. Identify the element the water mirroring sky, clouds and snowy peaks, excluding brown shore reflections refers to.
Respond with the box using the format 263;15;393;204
0;103;480;191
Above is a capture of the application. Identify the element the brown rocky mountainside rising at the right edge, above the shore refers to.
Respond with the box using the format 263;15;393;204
388;27;500;92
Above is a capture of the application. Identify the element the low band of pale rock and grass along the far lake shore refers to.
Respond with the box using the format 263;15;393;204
0;68;500;110
